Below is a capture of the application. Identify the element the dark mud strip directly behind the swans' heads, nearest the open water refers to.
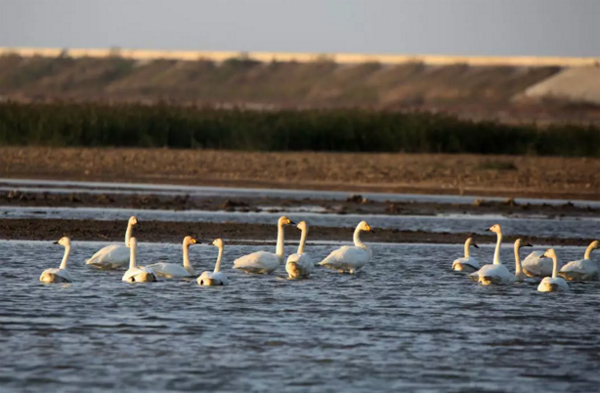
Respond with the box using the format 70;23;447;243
0;219;590;246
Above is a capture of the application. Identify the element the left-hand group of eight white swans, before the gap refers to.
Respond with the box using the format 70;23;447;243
40;216;372;286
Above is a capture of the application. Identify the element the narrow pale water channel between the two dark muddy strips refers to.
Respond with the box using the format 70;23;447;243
0;206;600;238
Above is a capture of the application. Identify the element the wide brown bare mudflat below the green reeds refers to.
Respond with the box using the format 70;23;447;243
0;147;600;200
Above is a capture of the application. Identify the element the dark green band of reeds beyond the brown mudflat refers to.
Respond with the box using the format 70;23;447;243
0;102;600;157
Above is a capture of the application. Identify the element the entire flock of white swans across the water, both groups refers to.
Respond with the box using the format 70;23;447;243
40;216;600;292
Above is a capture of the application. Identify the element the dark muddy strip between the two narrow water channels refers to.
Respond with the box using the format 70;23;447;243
0;190;600;218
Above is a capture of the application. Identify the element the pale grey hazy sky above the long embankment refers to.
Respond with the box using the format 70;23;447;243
0;0;600;57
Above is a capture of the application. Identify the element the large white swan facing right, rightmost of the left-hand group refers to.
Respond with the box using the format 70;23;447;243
319;221;375;274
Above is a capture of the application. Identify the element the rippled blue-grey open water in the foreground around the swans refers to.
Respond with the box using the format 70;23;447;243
0;241;600;392
